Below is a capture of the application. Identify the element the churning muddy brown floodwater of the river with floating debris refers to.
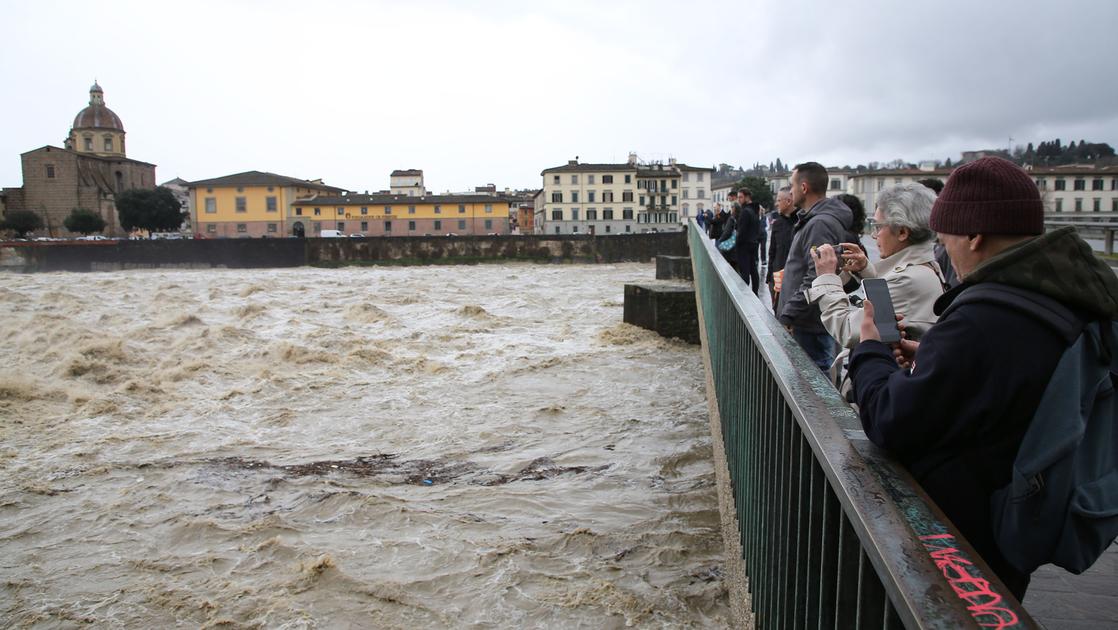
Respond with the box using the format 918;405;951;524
0;265;729;629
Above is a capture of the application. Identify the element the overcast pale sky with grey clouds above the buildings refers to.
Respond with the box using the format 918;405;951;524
0;0;1118;192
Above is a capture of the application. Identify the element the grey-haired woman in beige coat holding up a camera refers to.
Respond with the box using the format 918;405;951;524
808;183;945;347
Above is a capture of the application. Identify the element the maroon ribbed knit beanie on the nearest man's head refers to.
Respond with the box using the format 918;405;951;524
929;158;1044;235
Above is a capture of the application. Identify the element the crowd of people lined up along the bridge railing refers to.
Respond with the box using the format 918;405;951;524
704;158;1118;599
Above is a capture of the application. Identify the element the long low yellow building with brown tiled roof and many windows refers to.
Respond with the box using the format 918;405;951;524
287;194;513;237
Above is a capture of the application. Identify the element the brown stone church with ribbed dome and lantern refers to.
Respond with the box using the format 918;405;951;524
2;83;155;237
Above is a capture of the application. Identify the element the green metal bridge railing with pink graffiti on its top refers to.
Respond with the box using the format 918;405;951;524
688;221;1035;630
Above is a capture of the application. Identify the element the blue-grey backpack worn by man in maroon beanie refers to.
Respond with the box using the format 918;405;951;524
940;283;1118;574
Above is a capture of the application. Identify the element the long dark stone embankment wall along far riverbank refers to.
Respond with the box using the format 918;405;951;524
0;232;688;271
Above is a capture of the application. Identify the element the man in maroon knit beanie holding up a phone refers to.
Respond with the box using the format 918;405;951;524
850;158;1118;599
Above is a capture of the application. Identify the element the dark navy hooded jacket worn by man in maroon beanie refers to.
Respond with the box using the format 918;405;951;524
850;228;1118;596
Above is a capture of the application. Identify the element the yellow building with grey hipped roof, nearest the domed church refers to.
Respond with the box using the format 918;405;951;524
189;171;345;238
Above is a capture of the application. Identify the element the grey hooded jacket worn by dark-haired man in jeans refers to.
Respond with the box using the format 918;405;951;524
776;198;854;333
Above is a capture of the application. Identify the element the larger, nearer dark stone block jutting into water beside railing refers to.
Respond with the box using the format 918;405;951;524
625;284;699;344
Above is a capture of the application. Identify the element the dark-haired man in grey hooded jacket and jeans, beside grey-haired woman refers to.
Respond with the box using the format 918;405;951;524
776;162;854;372
